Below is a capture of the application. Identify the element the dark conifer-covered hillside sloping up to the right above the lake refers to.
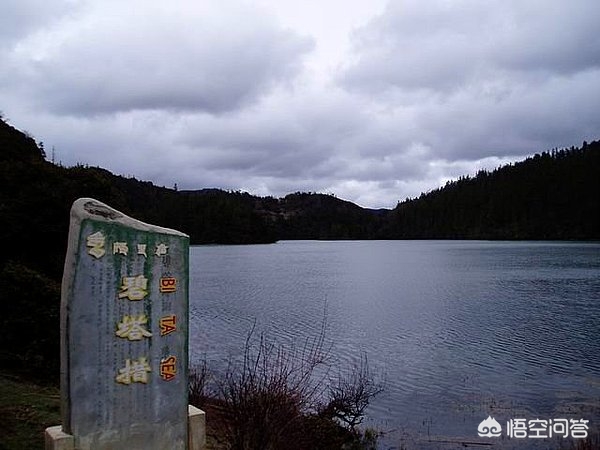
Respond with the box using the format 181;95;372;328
379;146;600;240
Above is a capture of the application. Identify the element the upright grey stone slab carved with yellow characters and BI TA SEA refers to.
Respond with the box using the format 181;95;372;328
61;199;189;450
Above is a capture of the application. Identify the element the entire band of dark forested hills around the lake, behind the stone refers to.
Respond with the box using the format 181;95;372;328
0;120;600;379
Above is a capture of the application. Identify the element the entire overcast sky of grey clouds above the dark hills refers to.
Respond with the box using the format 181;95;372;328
0;0;600;207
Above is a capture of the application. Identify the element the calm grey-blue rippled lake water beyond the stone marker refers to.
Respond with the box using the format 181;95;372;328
190;241;600;449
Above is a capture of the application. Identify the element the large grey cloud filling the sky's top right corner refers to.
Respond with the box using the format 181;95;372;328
342;0;600;93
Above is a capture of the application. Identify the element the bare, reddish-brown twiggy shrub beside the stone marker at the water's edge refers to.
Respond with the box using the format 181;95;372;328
190;323;381;450
